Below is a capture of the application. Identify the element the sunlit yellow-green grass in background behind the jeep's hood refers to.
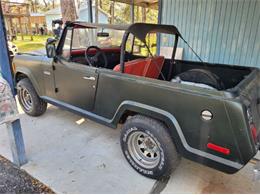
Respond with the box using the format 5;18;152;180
13;35;50;52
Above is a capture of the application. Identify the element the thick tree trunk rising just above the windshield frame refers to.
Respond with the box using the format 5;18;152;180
60;0;77;23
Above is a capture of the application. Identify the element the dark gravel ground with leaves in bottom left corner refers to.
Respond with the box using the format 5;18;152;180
0;156;54;194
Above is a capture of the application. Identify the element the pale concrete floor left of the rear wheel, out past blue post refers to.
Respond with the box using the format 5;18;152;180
0;106;155;193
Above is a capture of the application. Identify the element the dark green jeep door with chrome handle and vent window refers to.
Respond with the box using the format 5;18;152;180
54;29;98;111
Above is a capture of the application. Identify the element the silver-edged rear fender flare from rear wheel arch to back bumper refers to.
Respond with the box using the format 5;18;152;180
112;101;243;173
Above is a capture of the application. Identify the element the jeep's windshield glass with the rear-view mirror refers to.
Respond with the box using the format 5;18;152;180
72;28;124;49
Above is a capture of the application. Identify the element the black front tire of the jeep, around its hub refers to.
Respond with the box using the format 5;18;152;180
17;78;47;116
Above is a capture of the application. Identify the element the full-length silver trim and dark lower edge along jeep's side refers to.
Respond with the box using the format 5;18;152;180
41;96;244;173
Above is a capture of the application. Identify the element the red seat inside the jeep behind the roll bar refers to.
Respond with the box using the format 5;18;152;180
114;56;164;79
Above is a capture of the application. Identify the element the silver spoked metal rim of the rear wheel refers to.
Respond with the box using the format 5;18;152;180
127;131;160;169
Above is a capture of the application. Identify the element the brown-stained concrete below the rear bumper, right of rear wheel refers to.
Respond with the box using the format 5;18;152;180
162;159;260;194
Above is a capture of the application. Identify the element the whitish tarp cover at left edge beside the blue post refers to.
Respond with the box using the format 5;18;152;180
0;76;19;124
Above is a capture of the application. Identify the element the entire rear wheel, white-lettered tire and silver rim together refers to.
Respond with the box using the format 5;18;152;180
121;115;180;179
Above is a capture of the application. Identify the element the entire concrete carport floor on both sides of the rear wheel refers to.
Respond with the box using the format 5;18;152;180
0;102;260;193
